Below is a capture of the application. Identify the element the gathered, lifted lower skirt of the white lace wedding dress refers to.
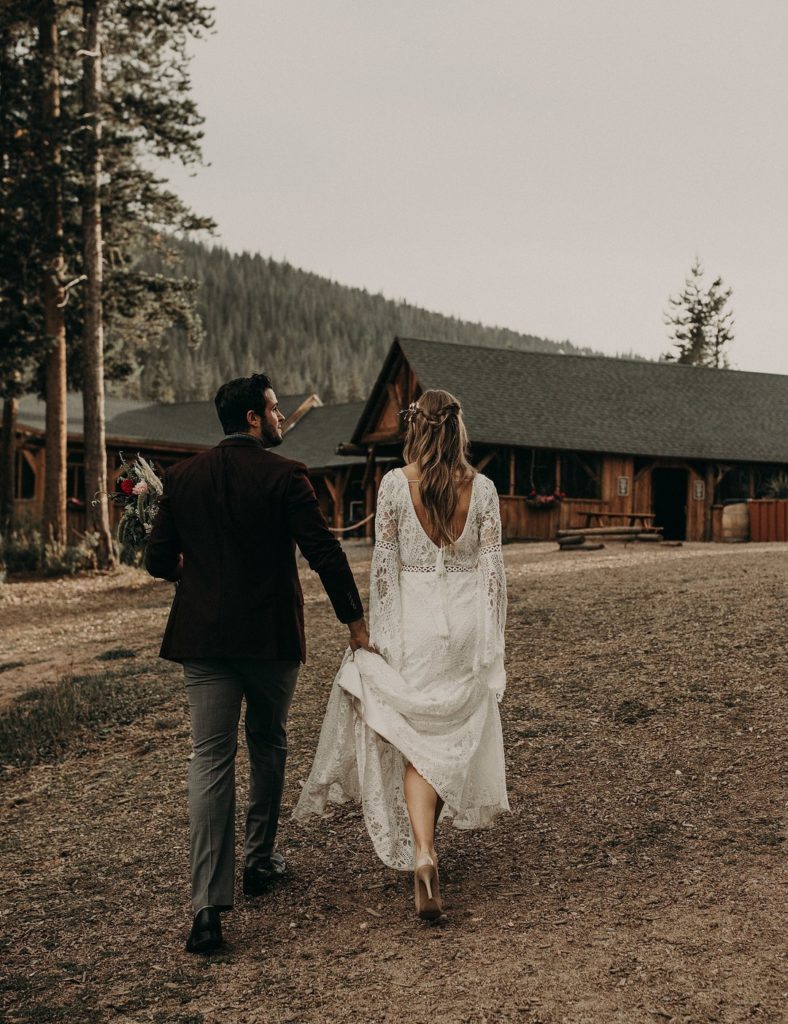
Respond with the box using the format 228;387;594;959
293;650;509;871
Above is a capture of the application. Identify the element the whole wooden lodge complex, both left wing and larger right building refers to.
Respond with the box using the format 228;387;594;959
6;338;788;541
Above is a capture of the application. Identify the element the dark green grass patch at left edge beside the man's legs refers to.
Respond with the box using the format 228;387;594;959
0;664;177;766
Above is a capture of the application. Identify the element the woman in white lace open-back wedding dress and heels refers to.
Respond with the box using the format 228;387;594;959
294;390;509;920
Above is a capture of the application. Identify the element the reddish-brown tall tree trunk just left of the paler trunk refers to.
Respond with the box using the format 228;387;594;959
38;0;67;544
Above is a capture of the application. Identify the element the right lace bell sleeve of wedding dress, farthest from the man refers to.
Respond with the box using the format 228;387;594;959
478;478;507;699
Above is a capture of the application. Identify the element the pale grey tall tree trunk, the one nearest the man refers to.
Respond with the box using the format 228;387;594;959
82;0;115;568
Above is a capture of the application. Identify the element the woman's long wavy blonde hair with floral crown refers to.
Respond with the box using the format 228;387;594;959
403;388;476;545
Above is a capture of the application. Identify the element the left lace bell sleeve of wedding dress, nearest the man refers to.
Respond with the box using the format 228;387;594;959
369;473;402;670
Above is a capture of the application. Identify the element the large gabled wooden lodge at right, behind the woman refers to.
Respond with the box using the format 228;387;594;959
342;338;788;541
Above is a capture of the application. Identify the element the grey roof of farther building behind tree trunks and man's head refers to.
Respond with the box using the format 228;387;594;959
17;394;313;450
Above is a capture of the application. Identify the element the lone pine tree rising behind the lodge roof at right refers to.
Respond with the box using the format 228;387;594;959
663;257;734;369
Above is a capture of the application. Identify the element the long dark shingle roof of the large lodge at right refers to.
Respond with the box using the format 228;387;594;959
384;338;788;463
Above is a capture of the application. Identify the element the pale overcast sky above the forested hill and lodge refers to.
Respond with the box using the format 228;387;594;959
162;0;788;373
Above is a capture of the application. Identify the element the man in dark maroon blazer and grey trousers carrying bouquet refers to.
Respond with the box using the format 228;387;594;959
145;374;368;952
